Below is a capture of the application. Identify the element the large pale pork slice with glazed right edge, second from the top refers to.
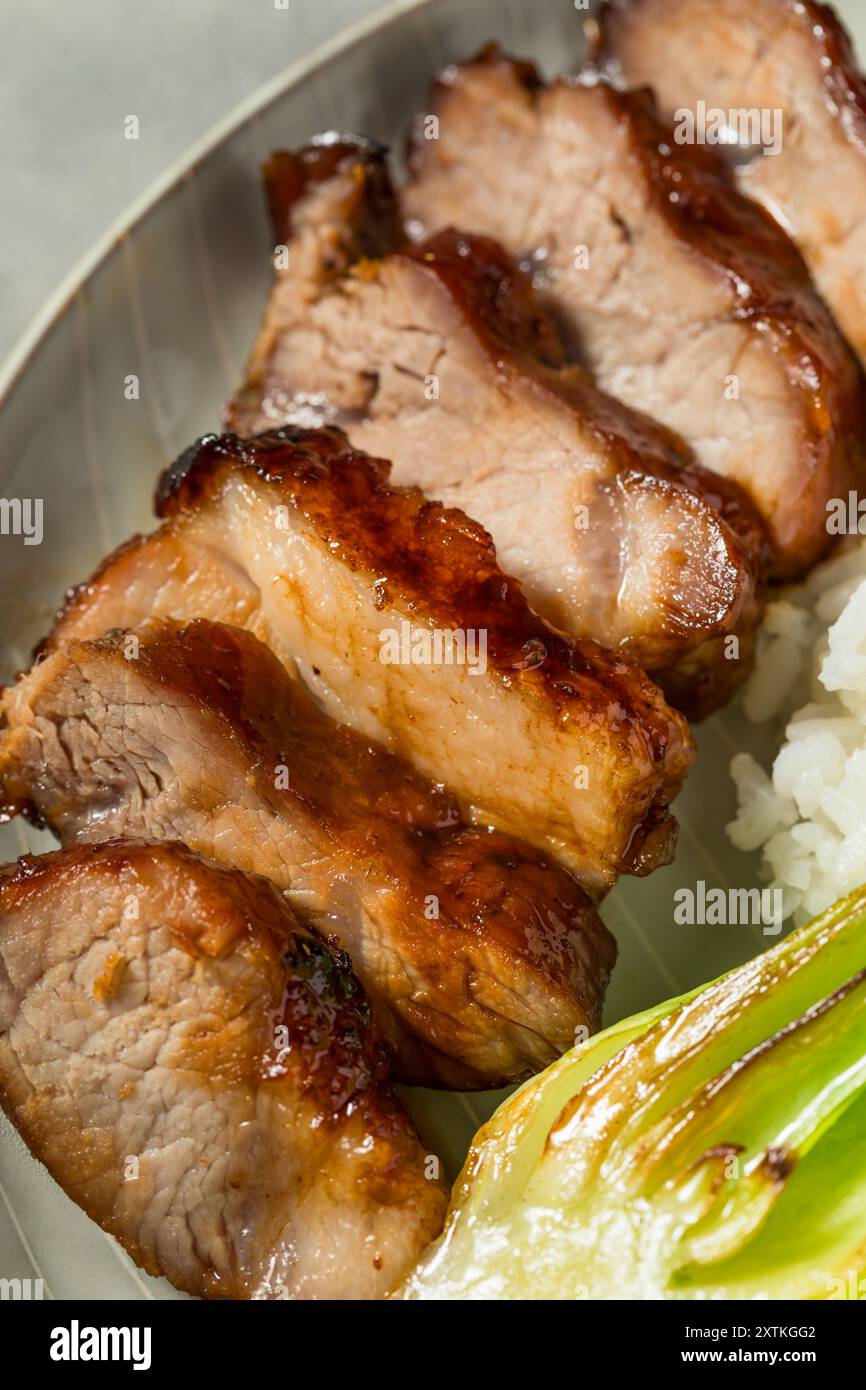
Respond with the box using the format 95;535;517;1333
405;42;863;577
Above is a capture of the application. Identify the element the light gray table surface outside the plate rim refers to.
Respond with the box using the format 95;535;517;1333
0;0;866;361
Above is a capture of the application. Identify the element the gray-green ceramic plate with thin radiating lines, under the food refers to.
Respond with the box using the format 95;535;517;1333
0;0;861;1298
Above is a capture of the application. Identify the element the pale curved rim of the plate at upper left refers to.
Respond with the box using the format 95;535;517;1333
0;0;439;411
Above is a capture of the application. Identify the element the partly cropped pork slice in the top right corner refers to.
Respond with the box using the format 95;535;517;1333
596;0;866;361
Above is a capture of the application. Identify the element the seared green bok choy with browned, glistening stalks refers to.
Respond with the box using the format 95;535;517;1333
399;888;866;1298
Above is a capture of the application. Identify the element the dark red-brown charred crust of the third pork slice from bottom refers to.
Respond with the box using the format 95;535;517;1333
157;425;694;778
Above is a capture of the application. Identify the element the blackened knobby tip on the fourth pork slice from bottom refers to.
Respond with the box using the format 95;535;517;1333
261;131;403;265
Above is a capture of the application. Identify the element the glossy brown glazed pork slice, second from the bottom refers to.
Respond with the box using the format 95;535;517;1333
0;621;616;1088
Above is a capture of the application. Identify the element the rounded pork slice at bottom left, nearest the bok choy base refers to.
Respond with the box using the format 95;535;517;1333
0;841;446;1298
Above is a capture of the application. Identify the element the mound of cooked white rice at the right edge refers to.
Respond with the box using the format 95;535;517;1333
728;538;866;920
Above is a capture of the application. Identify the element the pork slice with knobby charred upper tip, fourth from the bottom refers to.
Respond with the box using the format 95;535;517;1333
227;138;765;714
